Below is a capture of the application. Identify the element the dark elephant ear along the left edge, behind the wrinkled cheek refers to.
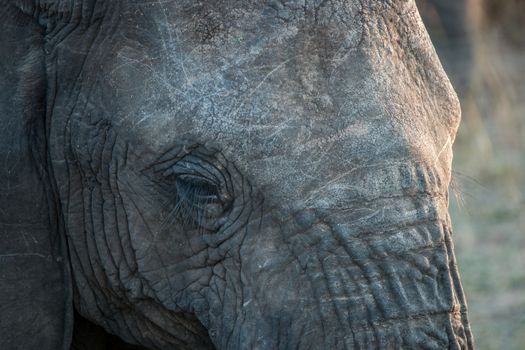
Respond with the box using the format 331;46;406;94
0;0;73;350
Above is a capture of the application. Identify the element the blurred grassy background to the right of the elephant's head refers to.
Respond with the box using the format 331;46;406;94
416;0;525;350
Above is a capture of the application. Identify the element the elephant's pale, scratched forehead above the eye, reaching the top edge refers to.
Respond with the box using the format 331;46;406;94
84;2;450;201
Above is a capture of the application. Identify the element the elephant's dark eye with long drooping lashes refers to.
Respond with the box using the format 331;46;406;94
175;174;229;230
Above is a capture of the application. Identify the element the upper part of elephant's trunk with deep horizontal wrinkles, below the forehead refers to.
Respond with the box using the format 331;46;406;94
210;163;473;349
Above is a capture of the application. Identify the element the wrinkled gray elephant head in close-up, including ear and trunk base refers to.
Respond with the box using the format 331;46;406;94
0;0;473;349
